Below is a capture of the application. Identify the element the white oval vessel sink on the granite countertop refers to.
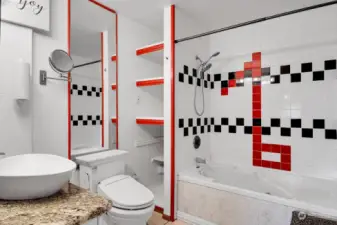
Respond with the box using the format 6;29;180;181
0;154;76;200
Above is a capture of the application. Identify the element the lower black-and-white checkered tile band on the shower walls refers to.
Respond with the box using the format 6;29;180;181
178;117;337;140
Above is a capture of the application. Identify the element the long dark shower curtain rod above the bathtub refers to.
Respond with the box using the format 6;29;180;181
175;0;337;43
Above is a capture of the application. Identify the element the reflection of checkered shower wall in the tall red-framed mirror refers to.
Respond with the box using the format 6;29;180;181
71;56;102;149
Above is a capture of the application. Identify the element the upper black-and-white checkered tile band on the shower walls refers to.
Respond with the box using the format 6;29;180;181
178;59;337;89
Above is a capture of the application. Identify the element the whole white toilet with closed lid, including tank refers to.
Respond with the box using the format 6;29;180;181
76;150;154;225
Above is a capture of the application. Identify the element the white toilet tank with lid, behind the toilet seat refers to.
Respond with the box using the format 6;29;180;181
76;150;128;192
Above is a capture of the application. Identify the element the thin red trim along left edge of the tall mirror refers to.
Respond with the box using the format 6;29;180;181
67;0;71;159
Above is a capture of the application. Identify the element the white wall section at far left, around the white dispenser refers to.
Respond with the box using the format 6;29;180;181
0;22;33;156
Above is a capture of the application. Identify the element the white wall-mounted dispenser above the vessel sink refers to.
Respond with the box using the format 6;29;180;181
14;62;30;100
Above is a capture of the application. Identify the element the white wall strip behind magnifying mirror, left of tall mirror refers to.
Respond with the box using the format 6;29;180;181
33;0;68;157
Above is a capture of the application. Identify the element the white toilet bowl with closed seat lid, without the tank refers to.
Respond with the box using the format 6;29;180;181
97;175;154;225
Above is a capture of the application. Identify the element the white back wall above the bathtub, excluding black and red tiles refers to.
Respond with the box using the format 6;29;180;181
206;6;337;177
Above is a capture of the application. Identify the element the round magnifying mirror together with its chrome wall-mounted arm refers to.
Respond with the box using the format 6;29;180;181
40;49;75;85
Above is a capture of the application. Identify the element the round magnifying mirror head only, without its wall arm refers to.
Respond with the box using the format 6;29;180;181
49;49;74;73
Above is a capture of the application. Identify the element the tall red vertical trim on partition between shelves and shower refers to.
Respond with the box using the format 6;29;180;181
170;5;176;221
